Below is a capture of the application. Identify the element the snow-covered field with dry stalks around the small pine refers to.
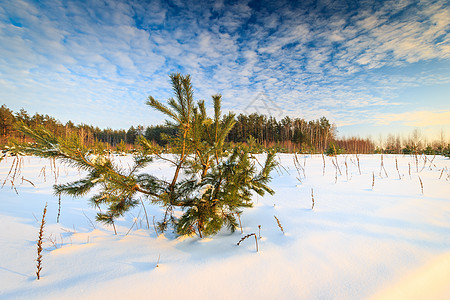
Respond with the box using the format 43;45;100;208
0;154;450;299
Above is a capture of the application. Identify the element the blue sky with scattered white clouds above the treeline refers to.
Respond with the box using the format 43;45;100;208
0;0;450;138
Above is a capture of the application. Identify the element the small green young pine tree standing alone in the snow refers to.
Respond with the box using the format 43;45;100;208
16;74;276;237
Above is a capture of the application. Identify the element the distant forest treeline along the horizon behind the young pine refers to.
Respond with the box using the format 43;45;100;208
0;105;450;154
